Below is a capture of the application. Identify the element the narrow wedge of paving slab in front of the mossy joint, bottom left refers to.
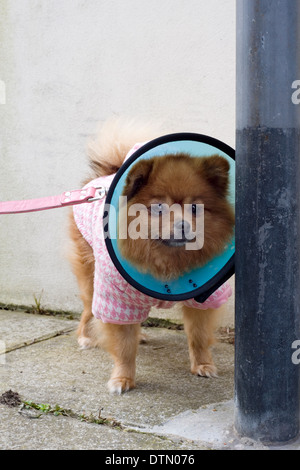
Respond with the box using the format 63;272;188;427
0;405;206;451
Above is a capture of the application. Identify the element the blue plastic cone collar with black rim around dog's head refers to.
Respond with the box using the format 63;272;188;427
105;133;235;302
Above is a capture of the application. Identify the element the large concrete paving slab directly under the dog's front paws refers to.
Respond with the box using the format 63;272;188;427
0;319;233;428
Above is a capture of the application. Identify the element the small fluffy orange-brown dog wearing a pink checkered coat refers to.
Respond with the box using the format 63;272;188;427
70;120;234;394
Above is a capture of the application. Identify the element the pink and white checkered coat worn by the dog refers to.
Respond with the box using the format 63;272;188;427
73;144;232;324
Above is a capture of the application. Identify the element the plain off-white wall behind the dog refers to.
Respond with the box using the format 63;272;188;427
0;0;235;320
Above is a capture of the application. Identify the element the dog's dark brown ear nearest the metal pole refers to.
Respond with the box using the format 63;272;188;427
200;155;230;197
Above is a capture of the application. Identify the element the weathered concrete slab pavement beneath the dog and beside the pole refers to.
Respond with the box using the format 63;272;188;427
0;310;300;452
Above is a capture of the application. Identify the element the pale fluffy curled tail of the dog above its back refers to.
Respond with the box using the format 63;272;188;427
88;118;159;178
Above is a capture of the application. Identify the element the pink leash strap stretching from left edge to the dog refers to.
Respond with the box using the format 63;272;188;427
0;186;107;215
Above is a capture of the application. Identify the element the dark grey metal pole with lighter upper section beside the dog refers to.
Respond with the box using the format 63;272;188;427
235;0;300;442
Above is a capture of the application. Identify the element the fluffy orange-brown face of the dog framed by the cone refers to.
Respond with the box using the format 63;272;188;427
118;154;234;280
